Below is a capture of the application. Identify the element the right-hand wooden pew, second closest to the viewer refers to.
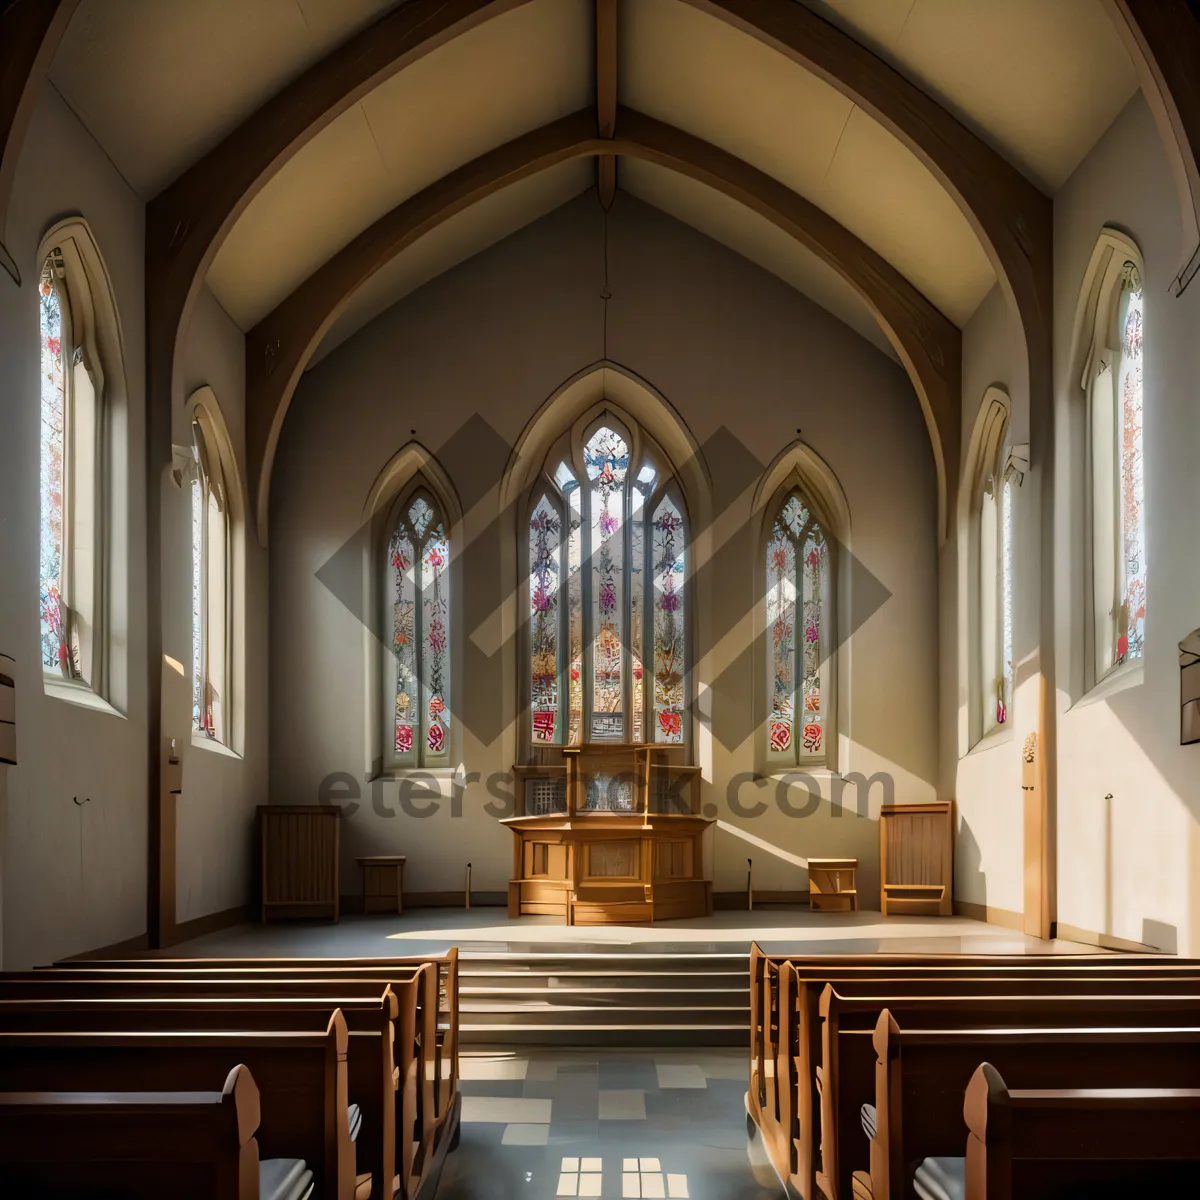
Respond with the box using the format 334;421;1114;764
852;1010;1200;1200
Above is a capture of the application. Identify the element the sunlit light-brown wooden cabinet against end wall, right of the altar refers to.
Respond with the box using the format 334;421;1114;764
880;800;954;917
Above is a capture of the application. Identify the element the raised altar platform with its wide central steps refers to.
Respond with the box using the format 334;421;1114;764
140;908;1094;1046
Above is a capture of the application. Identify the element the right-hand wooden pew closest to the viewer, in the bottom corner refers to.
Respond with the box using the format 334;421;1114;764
962;1062;1200;1200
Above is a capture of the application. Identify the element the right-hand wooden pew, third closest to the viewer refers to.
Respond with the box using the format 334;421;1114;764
817;980;1200;1200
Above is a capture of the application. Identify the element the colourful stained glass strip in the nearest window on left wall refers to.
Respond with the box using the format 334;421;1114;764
38;257;70;678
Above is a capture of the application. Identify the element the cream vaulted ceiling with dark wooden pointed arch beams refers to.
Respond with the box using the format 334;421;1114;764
44;0;1135;544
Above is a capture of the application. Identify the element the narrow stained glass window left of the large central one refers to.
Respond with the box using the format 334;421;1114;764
388;490;450;766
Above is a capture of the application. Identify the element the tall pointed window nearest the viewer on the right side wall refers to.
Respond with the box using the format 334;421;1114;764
1084;241;1147;682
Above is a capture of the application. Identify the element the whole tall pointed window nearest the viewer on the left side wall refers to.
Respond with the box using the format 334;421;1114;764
38;247;103;691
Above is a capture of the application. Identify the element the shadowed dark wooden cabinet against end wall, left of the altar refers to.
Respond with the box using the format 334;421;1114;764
258;804;342;920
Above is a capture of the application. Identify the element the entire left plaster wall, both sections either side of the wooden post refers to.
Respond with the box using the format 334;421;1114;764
0;88;266;968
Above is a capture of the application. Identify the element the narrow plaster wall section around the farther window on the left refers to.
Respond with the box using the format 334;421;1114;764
170;287;268;924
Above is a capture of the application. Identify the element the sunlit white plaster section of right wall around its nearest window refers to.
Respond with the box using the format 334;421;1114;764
1055;95;1200;954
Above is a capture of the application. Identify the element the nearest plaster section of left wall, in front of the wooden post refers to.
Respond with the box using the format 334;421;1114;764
0;88;146;968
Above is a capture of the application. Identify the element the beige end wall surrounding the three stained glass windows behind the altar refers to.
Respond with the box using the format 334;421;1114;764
270;194;937;902
